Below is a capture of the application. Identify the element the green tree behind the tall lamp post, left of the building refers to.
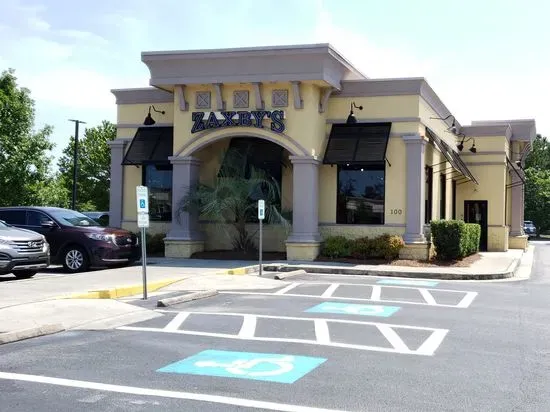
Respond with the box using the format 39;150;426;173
58;120;116;211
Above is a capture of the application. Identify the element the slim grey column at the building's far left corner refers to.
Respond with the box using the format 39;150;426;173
107;139;128;227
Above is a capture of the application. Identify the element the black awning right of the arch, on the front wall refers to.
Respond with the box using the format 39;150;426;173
323;122;391;164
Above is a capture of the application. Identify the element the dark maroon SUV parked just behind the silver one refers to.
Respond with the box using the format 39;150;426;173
0;206;141;272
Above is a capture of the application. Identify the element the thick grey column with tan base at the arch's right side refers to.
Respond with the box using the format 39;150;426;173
286;156;321;261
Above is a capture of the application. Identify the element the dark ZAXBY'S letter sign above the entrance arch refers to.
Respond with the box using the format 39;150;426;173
191;110;285;133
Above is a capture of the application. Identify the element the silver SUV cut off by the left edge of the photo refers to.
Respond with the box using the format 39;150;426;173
0;220;50;279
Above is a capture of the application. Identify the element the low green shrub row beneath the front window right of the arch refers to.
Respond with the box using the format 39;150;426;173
321;234;405;260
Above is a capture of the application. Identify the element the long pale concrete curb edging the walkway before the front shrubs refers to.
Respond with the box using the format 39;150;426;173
264;259;521;280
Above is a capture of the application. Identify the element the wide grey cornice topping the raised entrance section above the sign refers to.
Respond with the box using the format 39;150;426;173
141;43;366;89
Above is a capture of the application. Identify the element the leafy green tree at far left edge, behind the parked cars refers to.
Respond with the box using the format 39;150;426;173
0;69;54;206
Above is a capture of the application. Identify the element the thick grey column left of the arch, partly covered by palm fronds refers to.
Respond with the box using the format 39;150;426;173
164;157;204;258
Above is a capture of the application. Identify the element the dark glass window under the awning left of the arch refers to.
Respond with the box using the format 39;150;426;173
143;164;172;222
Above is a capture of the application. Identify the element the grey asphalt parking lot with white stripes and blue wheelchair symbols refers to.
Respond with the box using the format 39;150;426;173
0;251;550;412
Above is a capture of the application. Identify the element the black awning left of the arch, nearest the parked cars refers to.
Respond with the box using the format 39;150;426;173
122;126;174;165
